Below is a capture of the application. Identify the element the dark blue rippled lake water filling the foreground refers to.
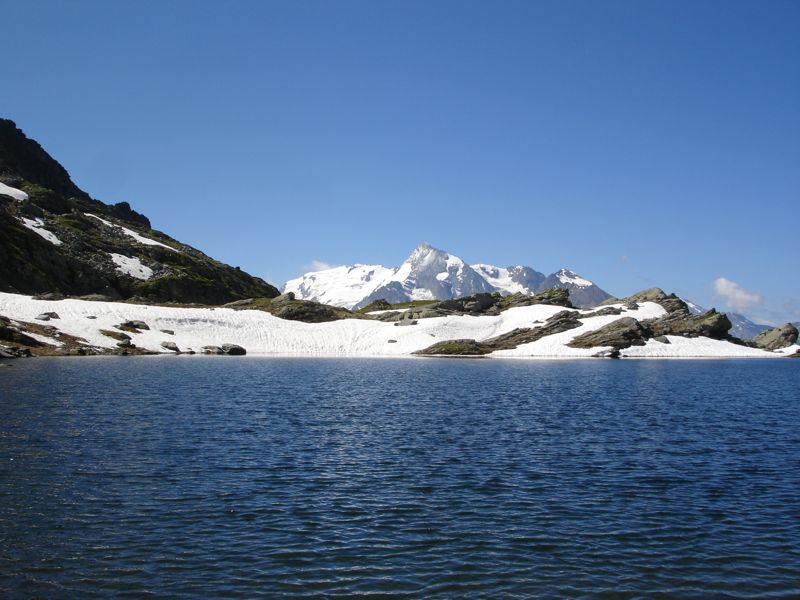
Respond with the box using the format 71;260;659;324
0;357;800;598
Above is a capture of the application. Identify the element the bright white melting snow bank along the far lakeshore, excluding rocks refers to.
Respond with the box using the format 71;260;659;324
0;293;778;358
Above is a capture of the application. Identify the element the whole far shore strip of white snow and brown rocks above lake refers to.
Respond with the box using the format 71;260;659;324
0;288;800;359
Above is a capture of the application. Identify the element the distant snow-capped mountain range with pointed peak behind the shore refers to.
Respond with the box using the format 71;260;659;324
283;244;611;309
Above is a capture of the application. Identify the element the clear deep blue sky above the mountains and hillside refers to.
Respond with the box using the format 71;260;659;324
0;0;800;321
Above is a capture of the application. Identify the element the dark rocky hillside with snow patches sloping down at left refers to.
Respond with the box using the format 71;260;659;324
0;119;279;304
